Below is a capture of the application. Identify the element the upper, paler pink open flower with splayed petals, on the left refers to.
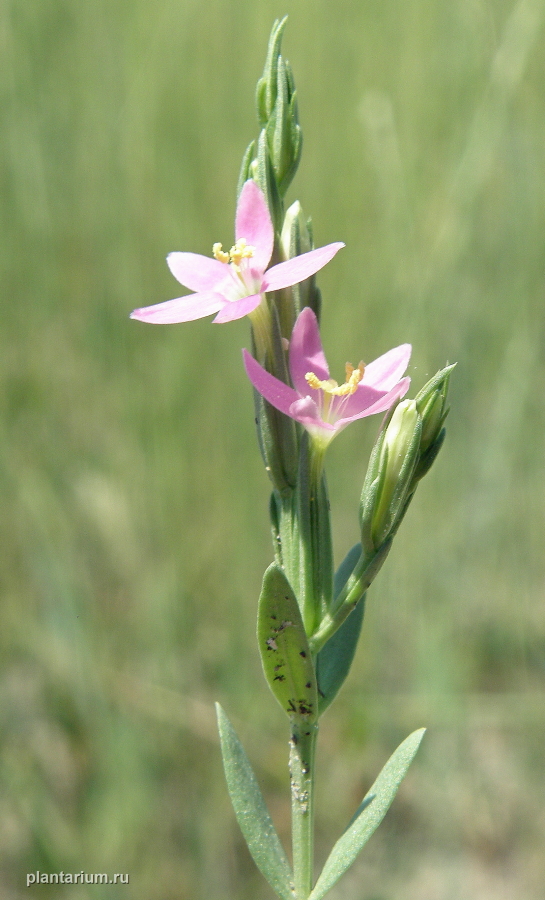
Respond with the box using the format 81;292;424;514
131;180;344;325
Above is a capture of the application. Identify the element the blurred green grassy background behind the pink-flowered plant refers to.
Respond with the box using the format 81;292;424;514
0;0;545;900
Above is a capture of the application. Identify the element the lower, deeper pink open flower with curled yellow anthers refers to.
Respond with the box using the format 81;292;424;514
243;306;411;447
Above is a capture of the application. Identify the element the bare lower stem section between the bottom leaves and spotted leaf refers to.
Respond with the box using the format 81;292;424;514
290;719;318;900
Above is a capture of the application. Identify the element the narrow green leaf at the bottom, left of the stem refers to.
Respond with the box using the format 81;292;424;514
216;703;294;900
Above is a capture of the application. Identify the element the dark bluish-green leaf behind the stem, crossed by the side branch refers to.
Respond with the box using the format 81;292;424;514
316;544;365;715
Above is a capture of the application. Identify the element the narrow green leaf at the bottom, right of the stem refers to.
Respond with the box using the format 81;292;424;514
309;728;426;900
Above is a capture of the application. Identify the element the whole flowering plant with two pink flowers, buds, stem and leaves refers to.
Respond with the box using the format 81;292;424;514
132;19;453;900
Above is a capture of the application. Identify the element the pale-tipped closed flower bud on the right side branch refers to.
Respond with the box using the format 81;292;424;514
361;400;422;548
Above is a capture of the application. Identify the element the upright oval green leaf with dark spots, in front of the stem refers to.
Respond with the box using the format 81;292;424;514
257;563;318;723
